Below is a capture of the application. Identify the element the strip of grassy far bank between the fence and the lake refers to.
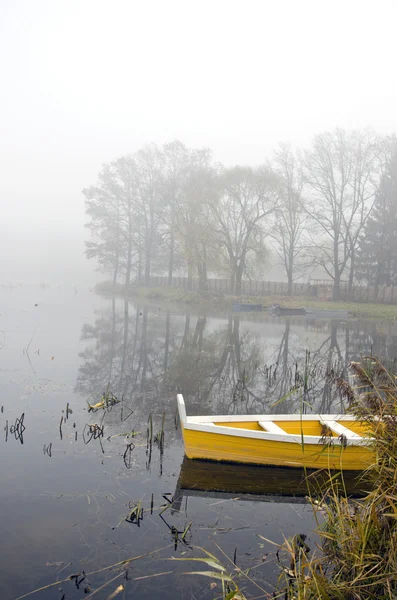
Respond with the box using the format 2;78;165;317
96;282;397;321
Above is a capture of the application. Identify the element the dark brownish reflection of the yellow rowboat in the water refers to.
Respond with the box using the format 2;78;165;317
173;457;368;510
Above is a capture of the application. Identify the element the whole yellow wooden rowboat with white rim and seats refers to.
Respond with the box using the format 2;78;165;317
178;394;374;471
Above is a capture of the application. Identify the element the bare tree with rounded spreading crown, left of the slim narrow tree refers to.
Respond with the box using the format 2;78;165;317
212;166;278;295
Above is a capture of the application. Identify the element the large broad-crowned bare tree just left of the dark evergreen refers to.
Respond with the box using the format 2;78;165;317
303;129;377;300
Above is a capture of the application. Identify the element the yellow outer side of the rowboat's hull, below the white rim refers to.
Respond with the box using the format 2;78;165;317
183;428;374;471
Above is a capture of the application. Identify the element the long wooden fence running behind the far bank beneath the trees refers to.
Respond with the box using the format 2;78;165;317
135;275;397;304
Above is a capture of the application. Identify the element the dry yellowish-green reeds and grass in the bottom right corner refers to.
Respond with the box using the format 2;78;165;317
280;357;397;600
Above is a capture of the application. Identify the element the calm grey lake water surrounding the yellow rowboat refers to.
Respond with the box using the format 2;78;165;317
0;286;397;600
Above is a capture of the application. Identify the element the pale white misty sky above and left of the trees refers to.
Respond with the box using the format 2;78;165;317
0;0;397;283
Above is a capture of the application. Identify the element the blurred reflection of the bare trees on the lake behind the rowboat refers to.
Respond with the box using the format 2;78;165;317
76;299;397;423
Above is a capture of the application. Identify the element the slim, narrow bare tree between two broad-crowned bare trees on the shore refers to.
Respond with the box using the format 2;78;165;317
269;144;307;296
